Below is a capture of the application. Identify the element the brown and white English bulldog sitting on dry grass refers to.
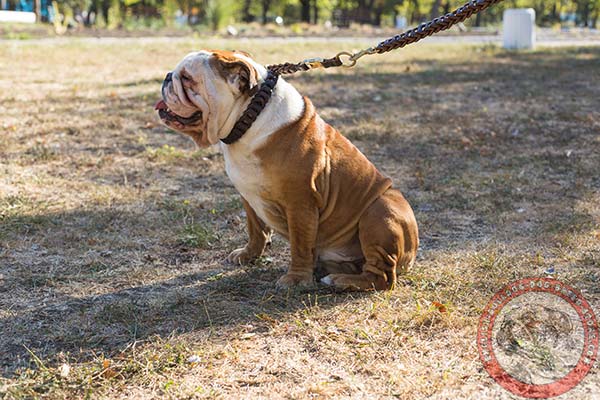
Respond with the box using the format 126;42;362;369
156;50;419;290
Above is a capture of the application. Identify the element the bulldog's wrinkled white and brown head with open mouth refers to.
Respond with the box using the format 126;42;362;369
155;50;266;147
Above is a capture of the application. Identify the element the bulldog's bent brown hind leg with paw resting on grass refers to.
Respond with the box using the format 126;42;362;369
321;189;419;290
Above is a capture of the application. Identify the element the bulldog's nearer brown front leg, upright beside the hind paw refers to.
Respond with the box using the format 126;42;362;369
277;204;319;288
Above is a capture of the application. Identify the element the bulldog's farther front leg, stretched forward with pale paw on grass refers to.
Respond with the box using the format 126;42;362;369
227;197;271;265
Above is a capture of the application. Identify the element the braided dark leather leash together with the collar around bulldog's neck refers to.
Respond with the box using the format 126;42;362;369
221;0;502;144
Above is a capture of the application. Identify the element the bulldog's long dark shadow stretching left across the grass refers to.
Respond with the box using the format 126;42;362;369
0;211;372;377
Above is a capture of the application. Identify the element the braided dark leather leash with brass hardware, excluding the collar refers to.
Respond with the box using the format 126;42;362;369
267;0;502;75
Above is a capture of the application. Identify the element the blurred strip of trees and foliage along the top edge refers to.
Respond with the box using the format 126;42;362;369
44;0;600;29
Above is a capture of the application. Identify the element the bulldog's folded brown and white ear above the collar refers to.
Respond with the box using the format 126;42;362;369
213;51;258;96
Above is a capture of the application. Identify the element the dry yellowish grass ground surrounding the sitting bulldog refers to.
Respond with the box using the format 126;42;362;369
0;39;600;399
